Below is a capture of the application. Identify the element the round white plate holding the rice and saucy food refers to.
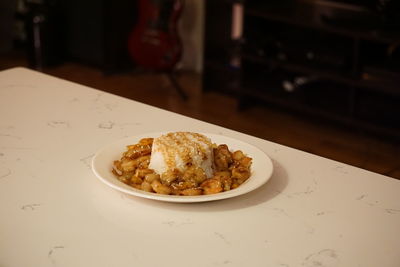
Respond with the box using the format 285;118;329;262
92;132;273;203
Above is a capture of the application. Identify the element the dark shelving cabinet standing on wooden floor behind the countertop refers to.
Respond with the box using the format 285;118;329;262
204;0;400;137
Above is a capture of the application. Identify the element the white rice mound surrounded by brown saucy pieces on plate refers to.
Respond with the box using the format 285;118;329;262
112;132;252;196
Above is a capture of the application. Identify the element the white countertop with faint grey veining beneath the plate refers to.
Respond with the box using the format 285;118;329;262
0;68;400;267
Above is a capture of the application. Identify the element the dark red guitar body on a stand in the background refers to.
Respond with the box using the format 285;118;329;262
128;0;183;71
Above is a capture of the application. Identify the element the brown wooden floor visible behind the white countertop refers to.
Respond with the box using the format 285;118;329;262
0;52;400;179
